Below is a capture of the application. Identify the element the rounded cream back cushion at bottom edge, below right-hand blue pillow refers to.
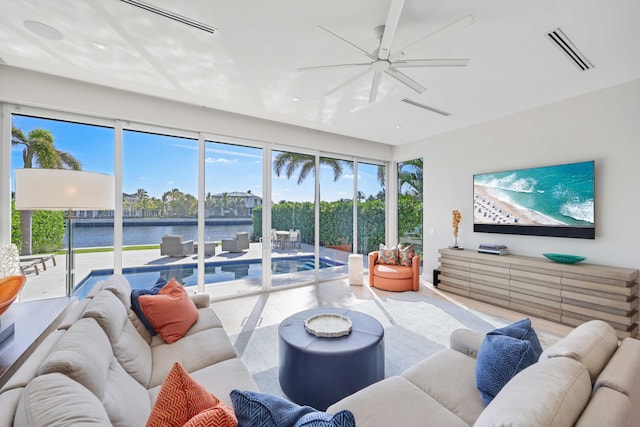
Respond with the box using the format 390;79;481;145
474;358;591;427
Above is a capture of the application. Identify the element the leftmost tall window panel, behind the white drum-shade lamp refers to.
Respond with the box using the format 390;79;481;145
11;114;114;300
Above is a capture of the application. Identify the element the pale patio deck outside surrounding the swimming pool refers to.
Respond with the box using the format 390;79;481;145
20;243;366;301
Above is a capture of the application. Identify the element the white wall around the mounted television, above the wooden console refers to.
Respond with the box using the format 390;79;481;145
394;80;640;281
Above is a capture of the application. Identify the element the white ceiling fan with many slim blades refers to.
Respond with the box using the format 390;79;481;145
298;0;473;102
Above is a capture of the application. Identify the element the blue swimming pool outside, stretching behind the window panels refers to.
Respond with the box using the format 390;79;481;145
73;255;345;299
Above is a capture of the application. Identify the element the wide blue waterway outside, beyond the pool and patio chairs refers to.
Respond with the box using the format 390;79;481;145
65;224;253;248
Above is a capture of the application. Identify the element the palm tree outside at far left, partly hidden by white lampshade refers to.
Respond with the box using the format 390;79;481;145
11;125;82;255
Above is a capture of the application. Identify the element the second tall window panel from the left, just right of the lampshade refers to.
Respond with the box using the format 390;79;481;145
122;130;198;288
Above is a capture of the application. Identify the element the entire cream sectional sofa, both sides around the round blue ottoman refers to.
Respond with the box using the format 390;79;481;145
0;276;640;427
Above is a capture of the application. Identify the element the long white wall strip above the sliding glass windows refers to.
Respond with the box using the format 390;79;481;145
0;65;392;160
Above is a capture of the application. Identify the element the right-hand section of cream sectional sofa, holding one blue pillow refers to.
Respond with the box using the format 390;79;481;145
327;320;640;427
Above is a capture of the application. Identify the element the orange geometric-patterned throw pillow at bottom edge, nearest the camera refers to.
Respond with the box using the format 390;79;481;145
147;362;238;427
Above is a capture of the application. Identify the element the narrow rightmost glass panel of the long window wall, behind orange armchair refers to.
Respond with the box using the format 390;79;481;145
356;162;386;266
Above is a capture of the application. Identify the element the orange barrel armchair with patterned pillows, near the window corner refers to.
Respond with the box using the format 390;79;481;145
369;251;420;292
